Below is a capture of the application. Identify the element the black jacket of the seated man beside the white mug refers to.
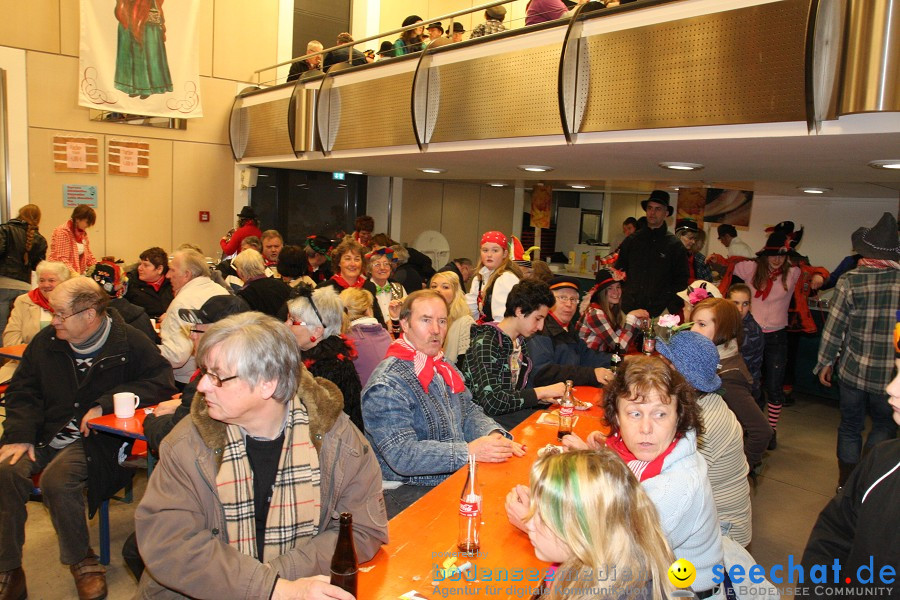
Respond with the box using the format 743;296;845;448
0;311;176;446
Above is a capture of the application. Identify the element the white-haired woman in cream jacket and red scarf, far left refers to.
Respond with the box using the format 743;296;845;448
0;260;72;382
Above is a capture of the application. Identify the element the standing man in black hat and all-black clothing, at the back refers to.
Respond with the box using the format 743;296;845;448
615;190;689;317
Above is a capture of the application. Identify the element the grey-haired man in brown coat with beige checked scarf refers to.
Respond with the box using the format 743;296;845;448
135;312;388;600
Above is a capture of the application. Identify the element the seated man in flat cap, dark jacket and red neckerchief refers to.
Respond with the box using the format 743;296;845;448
527;275;613;385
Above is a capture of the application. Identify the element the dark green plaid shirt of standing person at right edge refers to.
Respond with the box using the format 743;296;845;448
814;267;900;395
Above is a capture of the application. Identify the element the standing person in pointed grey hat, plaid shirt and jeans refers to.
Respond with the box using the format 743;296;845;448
814;212;900;487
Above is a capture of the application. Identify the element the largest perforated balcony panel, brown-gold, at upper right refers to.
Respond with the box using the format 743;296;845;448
581;0;809;131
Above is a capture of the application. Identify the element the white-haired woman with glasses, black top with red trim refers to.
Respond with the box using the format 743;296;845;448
286;284;365;433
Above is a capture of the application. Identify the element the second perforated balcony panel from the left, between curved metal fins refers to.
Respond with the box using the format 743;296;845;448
332;73;416;150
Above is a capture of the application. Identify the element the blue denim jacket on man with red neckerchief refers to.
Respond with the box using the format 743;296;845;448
362;357;511;485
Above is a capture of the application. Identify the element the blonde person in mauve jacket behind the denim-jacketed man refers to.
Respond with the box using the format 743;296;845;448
340;288;392;387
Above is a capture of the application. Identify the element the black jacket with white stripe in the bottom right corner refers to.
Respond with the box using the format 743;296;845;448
802;440;900;597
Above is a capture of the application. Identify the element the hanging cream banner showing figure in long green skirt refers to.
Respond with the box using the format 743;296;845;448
78;0;203;119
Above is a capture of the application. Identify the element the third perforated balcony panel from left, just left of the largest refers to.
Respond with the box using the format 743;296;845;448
431;44;562;143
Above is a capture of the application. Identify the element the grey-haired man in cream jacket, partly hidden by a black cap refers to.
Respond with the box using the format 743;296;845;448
159;250;228;389
